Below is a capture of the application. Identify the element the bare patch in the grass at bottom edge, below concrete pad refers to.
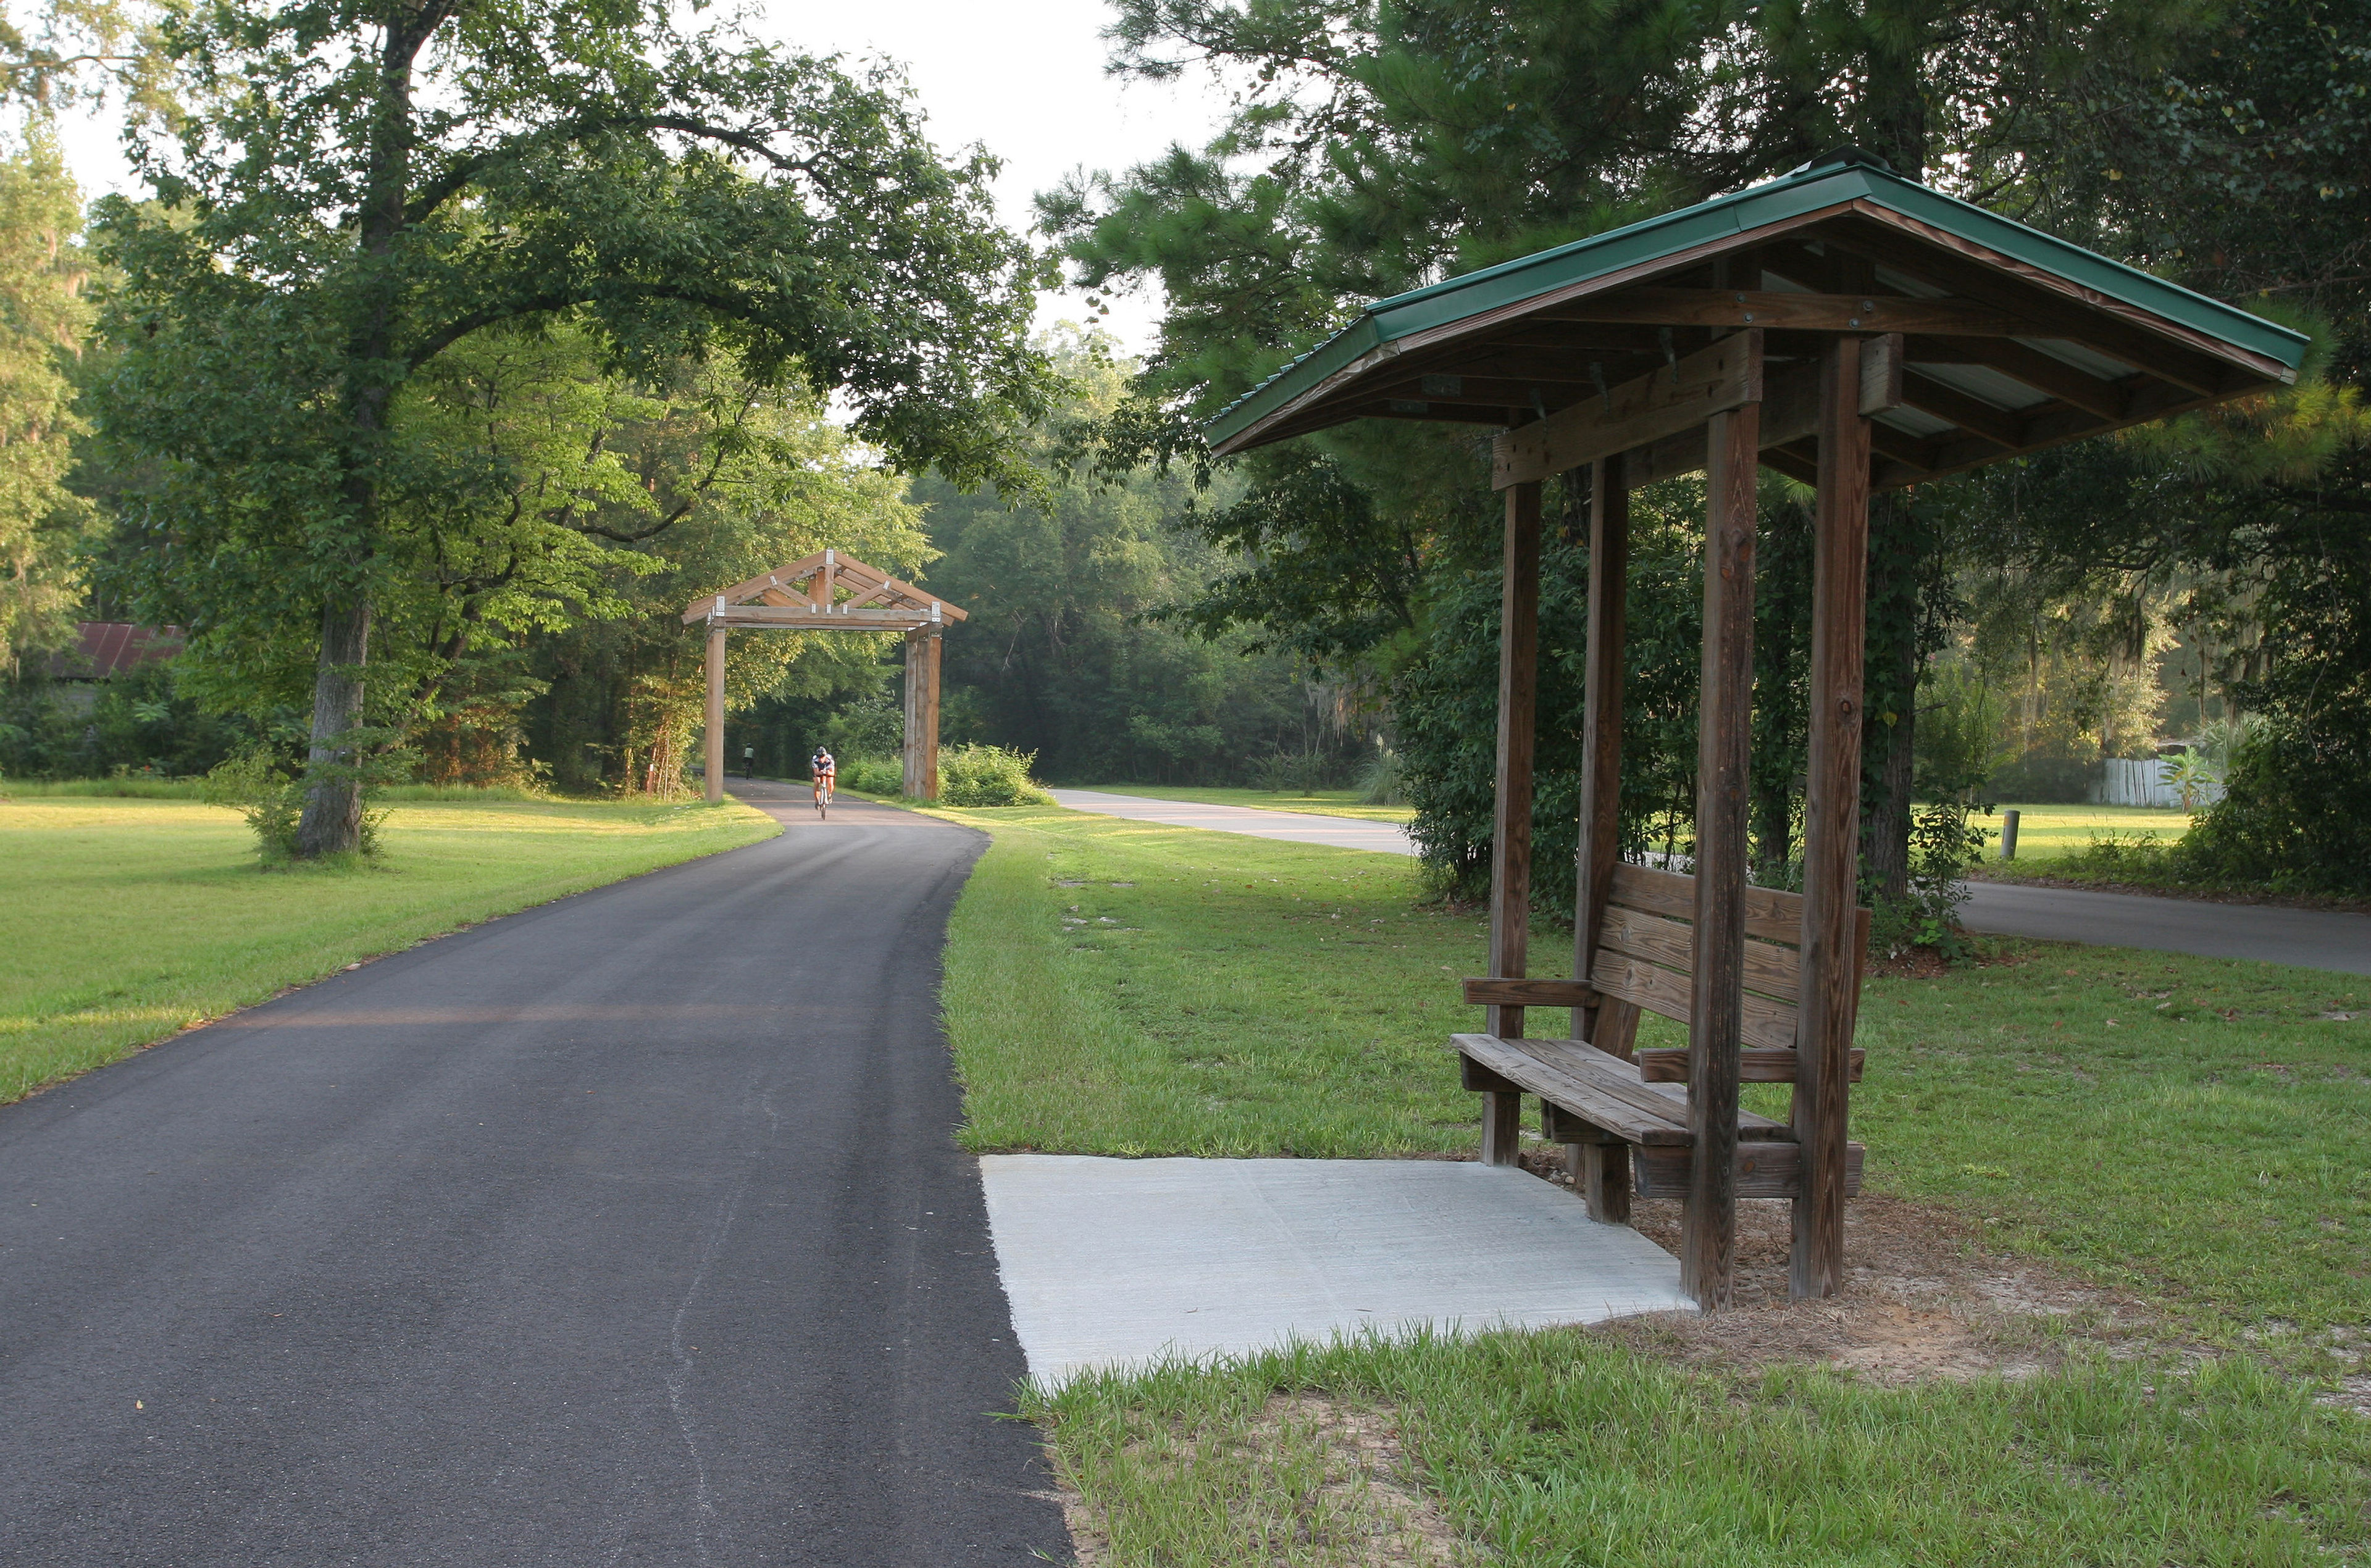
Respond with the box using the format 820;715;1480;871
1060;1393;1477;1568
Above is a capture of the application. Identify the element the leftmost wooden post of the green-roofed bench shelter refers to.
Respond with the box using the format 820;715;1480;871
1482;482;1539;1165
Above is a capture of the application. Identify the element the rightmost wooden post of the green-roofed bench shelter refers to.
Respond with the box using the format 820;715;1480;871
1788;337;1868;1300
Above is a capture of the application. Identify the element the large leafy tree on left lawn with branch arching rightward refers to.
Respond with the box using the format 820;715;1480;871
95;0;1045;854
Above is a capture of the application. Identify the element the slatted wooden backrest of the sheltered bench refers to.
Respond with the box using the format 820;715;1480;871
1589;866;1868;1051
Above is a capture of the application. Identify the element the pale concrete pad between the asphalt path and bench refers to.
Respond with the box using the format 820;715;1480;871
979;1155;1693;1385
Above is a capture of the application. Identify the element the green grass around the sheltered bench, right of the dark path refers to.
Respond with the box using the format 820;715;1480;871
924;811;2371;1568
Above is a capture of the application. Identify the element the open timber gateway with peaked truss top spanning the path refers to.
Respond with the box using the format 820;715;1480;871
683;550;968;807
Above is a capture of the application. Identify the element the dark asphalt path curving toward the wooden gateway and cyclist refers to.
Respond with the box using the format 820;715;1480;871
0;785;1069;1568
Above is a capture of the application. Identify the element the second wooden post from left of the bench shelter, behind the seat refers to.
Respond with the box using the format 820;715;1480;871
1572;453;1629;1056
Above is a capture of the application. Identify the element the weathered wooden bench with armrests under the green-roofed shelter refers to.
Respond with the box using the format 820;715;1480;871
1451;866;1868;1222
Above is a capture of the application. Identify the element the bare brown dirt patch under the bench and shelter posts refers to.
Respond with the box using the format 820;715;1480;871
1527;1157;2146;1383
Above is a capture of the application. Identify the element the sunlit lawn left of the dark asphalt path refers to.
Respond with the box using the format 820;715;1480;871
0;785;778;1103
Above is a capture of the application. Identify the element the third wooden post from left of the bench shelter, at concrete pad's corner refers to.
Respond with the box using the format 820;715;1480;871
1679;403;1762;1312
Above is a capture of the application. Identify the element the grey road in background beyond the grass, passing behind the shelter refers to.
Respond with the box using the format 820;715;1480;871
1053;790;2371;975
